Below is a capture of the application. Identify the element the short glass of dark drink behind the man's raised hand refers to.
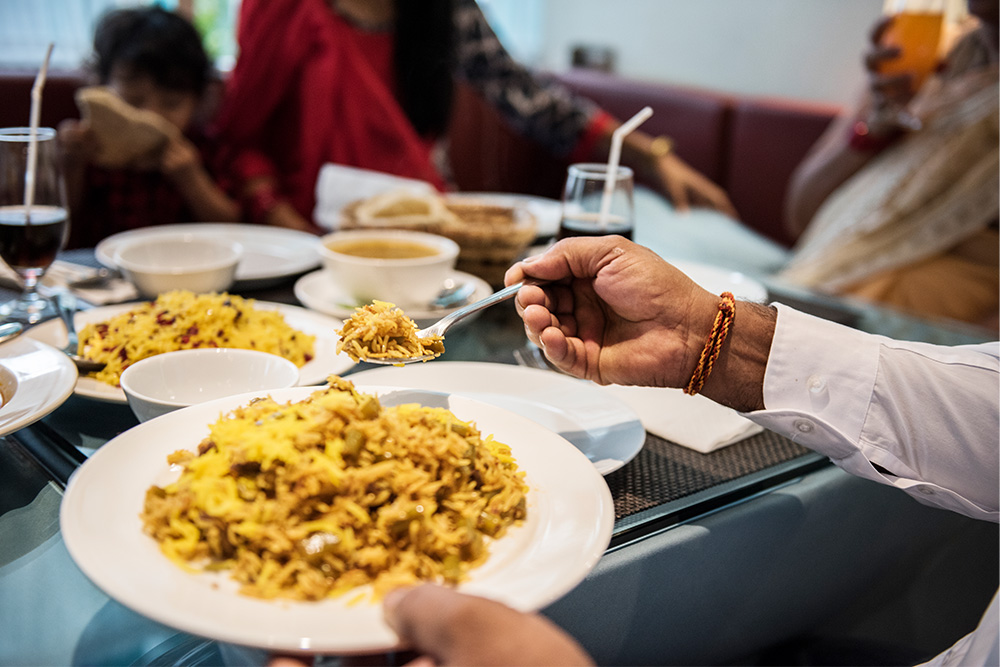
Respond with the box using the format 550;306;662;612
558;163;634;240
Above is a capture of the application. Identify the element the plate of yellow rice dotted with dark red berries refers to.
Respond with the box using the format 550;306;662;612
27;290;354;404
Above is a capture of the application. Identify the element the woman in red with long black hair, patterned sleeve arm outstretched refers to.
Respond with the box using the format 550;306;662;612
216;0;733;232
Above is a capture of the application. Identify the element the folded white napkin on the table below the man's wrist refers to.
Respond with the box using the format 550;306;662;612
606;385;763;454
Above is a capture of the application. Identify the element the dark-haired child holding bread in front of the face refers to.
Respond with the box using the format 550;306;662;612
59;8;240;247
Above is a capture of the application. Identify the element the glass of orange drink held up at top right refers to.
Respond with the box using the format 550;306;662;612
879;0;950;91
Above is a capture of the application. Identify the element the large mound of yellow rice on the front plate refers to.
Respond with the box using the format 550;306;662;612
141;377;527;600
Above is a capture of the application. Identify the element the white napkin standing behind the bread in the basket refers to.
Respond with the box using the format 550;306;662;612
313;164;435;230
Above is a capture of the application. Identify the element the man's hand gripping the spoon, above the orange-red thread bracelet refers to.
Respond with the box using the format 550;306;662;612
505;236;719;387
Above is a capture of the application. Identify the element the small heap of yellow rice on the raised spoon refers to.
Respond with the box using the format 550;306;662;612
337;301;444;361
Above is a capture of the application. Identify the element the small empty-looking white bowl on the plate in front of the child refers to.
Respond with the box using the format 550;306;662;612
114;234;243;298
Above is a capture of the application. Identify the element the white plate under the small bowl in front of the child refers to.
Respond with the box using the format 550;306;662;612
94;222;320;289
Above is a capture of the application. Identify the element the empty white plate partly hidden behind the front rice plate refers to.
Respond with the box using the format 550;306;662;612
347;361;646;475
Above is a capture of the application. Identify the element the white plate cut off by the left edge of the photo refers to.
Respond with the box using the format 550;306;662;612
0;335;76;436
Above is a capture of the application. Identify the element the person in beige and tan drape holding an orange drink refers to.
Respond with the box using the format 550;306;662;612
780;0;1000;329
